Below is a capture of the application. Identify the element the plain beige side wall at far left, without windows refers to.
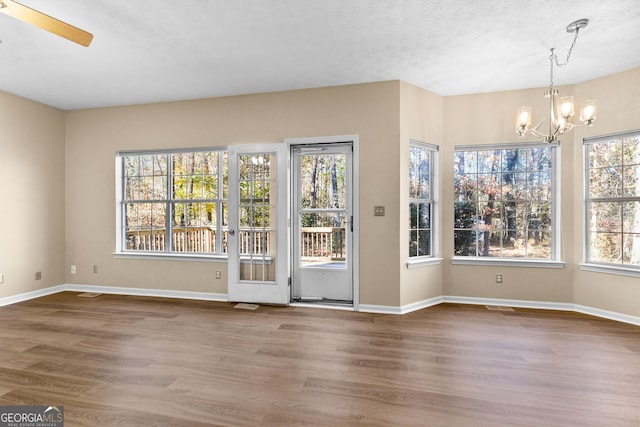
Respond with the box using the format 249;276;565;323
0;92;65;297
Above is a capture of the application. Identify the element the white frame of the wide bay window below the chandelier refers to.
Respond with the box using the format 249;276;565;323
451;141;565;268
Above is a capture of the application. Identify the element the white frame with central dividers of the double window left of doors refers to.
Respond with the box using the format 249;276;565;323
114;146;229;261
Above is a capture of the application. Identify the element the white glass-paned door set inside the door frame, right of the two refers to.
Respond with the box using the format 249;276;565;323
291;143;354;304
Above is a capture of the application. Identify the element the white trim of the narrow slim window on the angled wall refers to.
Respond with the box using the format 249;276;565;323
406;139;442;262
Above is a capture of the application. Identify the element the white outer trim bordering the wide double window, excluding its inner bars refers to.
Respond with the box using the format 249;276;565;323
112;146;229;262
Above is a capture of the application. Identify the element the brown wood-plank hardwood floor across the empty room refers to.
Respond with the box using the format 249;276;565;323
0;292;640;427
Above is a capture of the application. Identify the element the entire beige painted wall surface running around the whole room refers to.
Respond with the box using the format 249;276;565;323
0;68;640;316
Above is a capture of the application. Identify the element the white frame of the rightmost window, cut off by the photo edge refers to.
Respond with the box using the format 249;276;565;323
580;130;640;277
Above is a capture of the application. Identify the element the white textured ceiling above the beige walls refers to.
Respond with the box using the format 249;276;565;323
0;0;640;109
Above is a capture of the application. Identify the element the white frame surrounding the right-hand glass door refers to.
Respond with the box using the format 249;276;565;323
285;135;360;311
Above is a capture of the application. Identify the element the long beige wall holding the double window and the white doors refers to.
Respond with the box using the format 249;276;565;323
66;81;400;306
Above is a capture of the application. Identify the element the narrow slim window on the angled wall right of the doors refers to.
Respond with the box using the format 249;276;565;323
409;141;437;258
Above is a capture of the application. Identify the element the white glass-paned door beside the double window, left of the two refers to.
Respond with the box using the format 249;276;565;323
227;144;290;304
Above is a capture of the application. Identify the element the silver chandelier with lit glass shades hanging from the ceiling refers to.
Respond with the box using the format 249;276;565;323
516;19;596;142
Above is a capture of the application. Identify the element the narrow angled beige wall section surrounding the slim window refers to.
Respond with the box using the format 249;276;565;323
398;83;444;306
